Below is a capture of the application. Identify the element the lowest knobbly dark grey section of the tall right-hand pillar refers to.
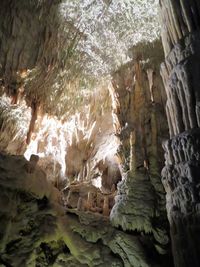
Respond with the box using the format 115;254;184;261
162;129;200;266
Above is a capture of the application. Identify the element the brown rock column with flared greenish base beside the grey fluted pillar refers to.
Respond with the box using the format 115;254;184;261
111;42;169;254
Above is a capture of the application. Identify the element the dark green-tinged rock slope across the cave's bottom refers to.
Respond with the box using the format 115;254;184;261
0;154;166;267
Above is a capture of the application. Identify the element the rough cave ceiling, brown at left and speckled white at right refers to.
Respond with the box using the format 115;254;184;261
0;0;159;116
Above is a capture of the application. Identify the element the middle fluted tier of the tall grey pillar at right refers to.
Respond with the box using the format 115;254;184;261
161;32;200;136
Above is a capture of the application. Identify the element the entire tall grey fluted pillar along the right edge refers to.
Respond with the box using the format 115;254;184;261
160;0;200;267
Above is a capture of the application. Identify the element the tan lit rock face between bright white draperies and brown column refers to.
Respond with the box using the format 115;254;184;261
65;111;121;190
